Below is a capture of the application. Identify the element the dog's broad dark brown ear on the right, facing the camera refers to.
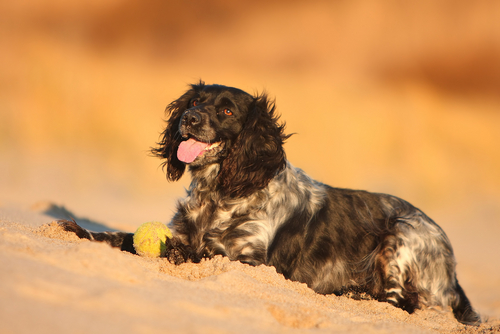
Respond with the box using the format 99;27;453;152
218;94;289;197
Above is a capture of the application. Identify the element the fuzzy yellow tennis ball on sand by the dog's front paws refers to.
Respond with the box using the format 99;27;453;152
133;222;172;257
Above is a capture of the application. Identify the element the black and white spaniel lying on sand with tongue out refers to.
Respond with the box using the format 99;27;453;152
62;82;480;324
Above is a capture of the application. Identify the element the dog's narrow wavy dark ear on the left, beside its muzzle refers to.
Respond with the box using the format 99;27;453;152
151;81;205;181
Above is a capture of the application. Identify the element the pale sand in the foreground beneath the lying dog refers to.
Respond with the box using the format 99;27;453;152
0;202;500;333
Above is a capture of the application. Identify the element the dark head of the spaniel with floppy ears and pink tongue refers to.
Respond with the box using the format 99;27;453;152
152;82;288;197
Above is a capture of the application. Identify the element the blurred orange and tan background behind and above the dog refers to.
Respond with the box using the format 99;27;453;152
0;0;500;235
